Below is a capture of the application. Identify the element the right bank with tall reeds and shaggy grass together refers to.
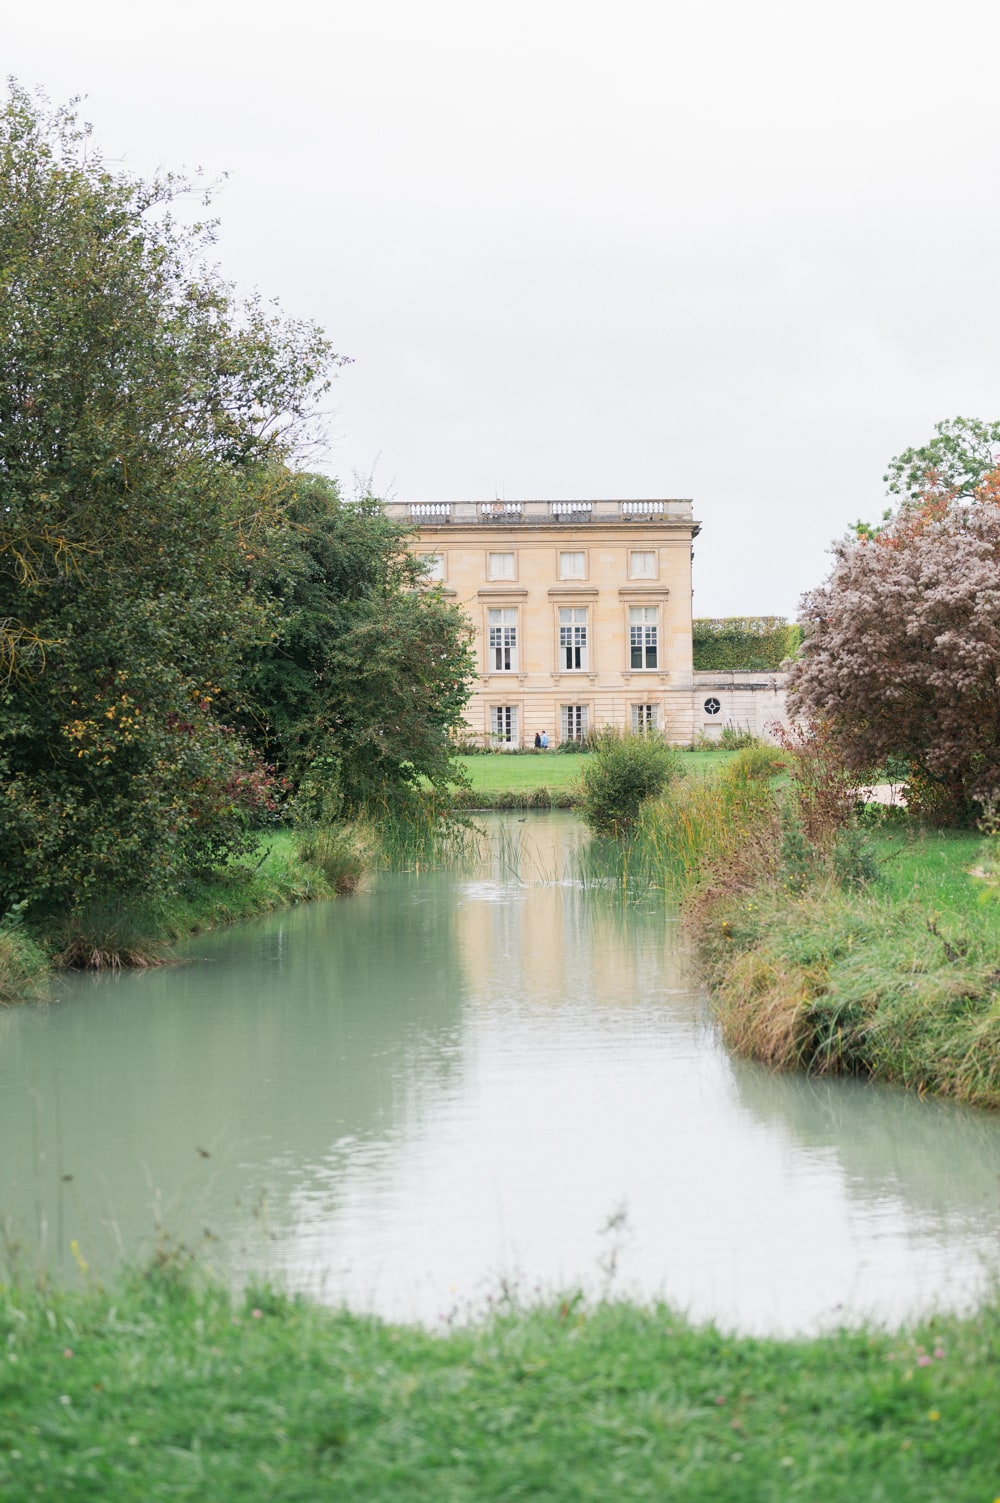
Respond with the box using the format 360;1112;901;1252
583;759;1000;1108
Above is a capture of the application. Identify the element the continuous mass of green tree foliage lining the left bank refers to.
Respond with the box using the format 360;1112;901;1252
0;84;468;912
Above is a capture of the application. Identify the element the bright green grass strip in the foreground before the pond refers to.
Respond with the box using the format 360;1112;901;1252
0;1267;1000;1503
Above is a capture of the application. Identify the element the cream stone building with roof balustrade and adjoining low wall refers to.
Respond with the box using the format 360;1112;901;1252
385;500;783;748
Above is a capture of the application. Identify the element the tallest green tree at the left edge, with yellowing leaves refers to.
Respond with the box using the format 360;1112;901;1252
0;87;334;912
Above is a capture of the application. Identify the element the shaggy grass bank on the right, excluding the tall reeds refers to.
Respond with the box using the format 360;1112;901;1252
698;825;1000;1108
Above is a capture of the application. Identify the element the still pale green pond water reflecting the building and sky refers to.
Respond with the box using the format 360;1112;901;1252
0;815;1000;1332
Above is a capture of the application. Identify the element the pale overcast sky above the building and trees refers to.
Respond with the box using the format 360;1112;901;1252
7;0;1000;615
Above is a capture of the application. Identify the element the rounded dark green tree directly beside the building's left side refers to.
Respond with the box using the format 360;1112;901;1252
244;475;475;815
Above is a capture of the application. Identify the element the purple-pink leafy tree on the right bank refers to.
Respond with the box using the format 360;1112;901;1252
789;469;1000;818
